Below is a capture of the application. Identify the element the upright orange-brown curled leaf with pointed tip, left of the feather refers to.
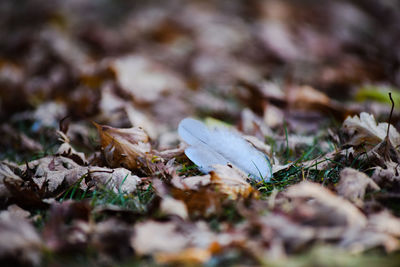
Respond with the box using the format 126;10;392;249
94;123;151;169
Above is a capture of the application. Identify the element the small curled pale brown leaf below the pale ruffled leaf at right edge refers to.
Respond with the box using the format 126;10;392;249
336;168;380;206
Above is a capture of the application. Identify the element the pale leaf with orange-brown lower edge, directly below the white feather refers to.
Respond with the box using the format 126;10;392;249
210;164;258;199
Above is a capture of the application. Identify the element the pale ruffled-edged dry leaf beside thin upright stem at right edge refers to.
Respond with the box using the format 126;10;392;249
343;112;400;150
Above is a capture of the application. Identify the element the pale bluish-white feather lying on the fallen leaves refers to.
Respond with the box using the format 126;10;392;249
178;118;272;181
